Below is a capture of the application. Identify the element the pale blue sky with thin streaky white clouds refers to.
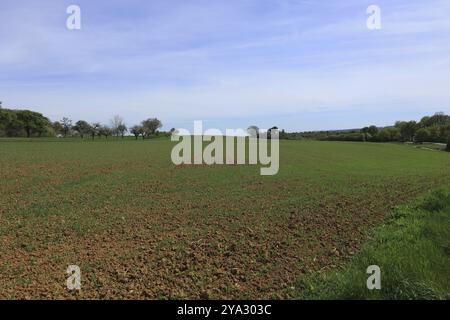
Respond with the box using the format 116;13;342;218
0;0;450;131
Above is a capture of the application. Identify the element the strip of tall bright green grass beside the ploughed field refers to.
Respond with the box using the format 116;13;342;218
296;186;450;299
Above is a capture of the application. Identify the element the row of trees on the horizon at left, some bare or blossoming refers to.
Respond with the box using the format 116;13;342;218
0;107;162;139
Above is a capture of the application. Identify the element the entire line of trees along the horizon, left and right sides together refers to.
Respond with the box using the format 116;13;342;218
0;103;450;151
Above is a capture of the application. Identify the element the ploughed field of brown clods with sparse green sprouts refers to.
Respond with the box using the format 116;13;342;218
0;139;450;299
